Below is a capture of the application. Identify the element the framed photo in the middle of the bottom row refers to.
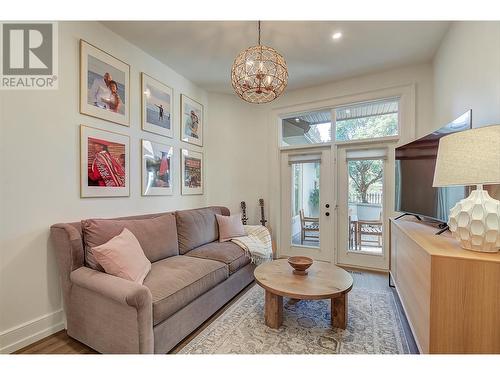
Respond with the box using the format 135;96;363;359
142;139;174;195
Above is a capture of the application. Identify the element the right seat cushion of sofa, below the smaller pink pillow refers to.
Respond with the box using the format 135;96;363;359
186;242;250;275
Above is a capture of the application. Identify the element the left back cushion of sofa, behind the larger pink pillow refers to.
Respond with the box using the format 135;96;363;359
82;213;179;271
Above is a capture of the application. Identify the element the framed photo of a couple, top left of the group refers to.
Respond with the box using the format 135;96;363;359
80;40;130;126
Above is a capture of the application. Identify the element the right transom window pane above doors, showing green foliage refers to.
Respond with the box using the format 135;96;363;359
335;98;399;141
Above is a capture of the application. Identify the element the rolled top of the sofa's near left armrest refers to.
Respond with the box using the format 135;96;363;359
70;267;152;309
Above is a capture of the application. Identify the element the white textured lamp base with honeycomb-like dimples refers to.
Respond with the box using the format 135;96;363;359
448;188;500;253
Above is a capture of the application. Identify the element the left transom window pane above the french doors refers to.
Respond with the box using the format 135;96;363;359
281;111;332;146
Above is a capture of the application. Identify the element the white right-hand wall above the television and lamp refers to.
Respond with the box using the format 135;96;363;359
434;21;500;128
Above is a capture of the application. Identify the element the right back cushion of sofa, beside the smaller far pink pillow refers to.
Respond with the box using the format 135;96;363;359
175;207;229;254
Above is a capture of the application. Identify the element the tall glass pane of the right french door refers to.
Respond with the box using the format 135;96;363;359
347;160;384;255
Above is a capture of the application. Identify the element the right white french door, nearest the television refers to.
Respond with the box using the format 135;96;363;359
337;145;394;270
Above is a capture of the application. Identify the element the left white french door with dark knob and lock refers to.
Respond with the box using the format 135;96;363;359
278;147;335;262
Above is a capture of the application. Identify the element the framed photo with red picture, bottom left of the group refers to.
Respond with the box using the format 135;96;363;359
80;125;130;198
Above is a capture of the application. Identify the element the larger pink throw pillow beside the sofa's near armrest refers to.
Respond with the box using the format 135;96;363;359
92;228;151;284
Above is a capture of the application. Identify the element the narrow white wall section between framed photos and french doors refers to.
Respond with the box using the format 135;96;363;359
205;93;269;224
